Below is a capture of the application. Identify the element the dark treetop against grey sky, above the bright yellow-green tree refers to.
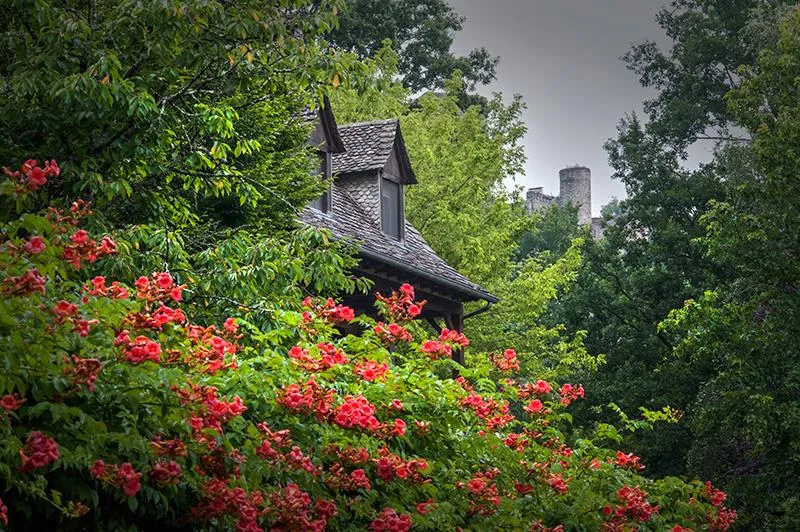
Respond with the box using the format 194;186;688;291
331;0;499;92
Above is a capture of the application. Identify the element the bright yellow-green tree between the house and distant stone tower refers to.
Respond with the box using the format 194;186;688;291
332;47;597;386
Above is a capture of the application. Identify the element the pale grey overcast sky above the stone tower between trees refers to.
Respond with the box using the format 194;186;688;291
449;0;668;216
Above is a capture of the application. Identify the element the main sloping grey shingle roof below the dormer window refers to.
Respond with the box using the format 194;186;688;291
300;186;497;303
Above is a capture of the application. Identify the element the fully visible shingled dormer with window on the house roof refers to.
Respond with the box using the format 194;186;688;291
333;119;417;241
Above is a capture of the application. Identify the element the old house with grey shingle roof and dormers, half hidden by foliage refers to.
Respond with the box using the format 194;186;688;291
300;105;497;362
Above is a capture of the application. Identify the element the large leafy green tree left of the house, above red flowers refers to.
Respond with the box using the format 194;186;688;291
0;0;376;326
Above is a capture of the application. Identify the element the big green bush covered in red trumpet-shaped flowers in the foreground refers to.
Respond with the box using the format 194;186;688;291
0;161;736;530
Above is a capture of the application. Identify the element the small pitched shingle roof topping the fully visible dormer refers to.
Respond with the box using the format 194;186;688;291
333;119;417;185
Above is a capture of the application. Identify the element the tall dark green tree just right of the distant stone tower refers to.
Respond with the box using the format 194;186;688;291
551;0;800;482
